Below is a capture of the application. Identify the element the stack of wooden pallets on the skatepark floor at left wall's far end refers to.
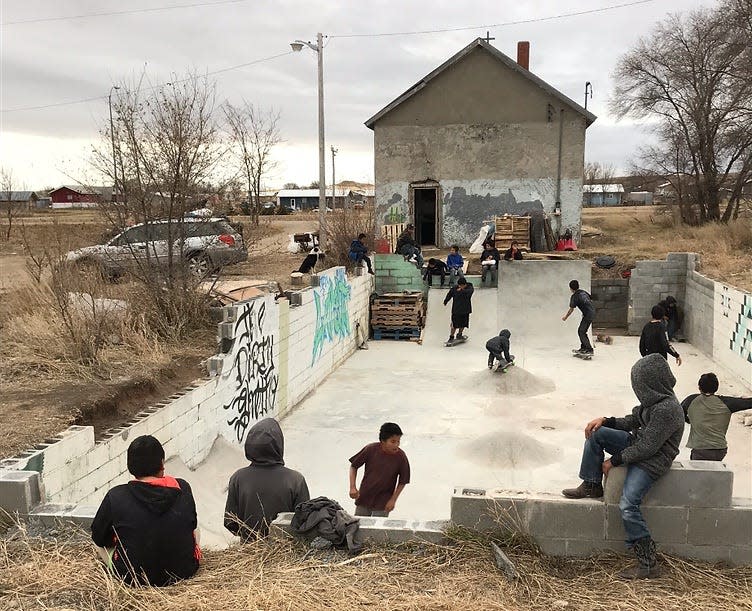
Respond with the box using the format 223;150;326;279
371;292;424;339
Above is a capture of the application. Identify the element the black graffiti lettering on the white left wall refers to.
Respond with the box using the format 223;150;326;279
222;300;279;443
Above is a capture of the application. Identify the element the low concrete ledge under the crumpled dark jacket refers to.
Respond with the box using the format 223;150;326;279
269;513;449;543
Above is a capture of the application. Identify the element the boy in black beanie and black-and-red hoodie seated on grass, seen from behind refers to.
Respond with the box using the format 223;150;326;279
91;435;201;586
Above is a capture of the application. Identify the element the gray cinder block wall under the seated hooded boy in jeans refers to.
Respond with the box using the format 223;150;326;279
451;461;752;566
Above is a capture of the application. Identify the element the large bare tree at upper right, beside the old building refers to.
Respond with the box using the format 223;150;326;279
611;0;752;223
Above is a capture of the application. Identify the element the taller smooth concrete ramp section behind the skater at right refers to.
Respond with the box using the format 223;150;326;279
497;261;591;353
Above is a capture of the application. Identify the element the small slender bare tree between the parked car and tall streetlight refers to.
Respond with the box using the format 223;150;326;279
224;102;282;225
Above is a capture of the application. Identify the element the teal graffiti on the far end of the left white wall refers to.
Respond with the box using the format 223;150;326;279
311;269;350;365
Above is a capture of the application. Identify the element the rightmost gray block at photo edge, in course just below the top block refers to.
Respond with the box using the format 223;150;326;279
687;507;752;548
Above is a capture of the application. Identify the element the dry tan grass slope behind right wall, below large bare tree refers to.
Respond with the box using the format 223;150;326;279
579;206;752;291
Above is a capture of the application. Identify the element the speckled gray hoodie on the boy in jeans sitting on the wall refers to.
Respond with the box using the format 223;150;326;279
603;354;684;480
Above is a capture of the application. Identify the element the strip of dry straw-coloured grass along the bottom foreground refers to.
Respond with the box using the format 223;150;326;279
0;531;752;611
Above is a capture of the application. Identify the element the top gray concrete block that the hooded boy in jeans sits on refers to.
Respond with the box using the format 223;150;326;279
604;460;734;507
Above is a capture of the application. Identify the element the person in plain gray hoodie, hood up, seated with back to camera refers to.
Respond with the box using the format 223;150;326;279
225;418;310;541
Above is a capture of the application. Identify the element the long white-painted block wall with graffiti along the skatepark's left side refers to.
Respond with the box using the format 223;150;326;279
0;267;373;516
